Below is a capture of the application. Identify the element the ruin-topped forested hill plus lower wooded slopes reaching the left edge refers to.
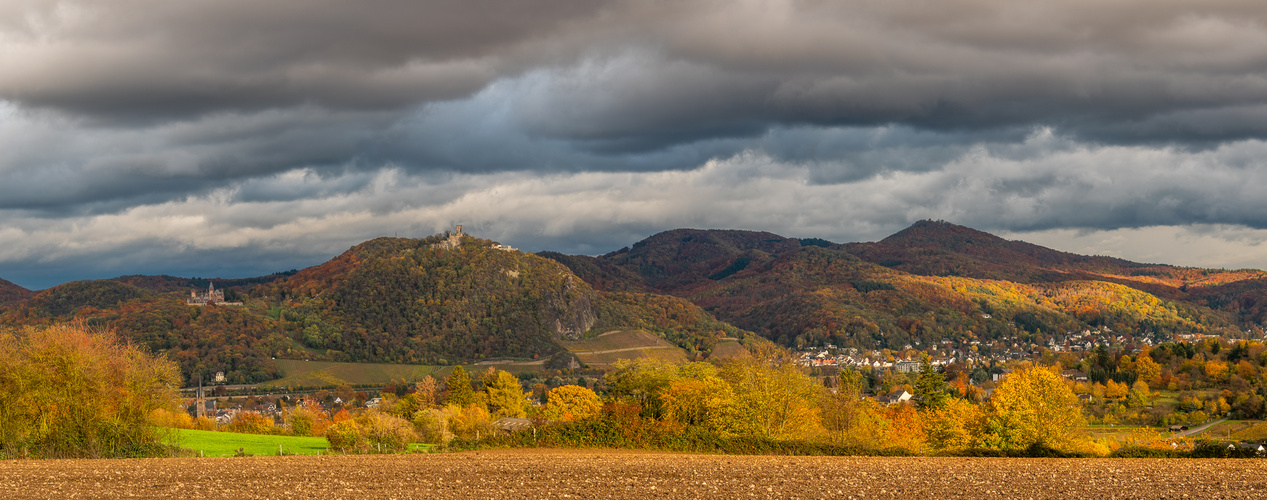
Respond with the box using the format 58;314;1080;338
0;231;758;384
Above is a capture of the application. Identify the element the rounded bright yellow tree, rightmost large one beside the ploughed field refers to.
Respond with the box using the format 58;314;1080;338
982;367;1086;451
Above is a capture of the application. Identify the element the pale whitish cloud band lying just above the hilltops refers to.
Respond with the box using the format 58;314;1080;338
7;130;1267;286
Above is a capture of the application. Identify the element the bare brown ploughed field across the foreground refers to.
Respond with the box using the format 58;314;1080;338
0;449;1267;500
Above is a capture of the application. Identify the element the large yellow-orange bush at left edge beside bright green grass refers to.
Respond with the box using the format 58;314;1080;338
0;325;180;458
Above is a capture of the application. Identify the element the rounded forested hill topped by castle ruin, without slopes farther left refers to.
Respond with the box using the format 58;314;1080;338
253;235;741;363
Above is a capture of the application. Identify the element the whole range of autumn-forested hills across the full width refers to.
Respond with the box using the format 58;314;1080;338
9;222;1267;382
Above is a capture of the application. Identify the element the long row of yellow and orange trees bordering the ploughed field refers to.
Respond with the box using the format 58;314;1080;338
176;351;1109;456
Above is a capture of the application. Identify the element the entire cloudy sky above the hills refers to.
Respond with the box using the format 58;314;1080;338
0;0;1267;289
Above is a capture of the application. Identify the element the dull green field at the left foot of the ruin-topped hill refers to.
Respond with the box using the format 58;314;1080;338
260;359;441;387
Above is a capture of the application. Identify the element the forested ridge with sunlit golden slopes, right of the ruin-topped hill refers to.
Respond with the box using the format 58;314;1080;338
545;222;1267;347
